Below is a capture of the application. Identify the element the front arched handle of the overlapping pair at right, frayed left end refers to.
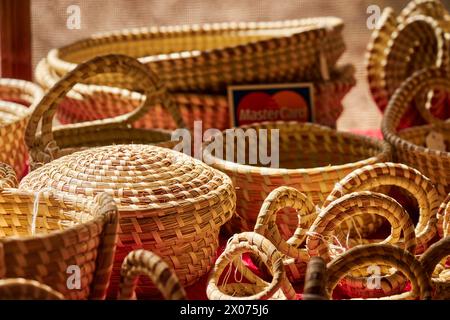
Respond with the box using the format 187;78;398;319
306;191;416;262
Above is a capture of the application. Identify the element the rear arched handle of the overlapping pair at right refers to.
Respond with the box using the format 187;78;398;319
323;162;440;253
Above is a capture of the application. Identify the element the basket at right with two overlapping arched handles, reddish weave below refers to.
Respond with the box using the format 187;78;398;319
307;163;439;298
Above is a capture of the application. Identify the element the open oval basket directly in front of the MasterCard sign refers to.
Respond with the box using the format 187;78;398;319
203;122;390;237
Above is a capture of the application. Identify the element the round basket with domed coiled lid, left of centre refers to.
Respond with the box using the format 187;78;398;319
20;144;236;296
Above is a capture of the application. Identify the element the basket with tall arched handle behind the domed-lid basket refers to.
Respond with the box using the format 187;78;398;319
25;55;184;168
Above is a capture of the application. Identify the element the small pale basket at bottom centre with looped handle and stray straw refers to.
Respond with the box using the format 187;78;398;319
206;232;295;300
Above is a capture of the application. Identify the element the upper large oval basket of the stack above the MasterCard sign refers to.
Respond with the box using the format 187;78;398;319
47;17;345;93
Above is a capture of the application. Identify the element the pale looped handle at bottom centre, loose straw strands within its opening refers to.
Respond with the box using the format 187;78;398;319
206;232;295;300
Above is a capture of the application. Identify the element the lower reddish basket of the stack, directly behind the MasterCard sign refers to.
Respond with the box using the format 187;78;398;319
36;59;356;130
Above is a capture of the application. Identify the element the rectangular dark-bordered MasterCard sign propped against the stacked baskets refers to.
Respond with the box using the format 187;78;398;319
228;83;314;126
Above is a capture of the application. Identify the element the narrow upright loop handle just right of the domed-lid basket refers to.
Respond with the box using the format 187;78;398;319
254;187;317;261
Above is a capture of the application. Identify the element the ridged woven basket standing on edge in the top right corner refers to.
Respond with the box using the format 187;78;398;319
367;0;450;110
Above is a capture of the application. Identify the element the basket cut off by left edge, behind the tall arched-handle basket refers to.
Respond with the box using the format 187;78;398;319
0;79;43;178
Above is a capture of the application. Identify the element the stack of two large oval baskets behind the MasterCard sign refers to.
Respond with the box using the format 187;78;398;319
36;17;355;129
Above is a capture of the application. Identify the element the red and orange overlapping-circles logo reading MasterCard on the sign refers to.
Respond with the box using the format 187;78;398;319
237;90;310;125
